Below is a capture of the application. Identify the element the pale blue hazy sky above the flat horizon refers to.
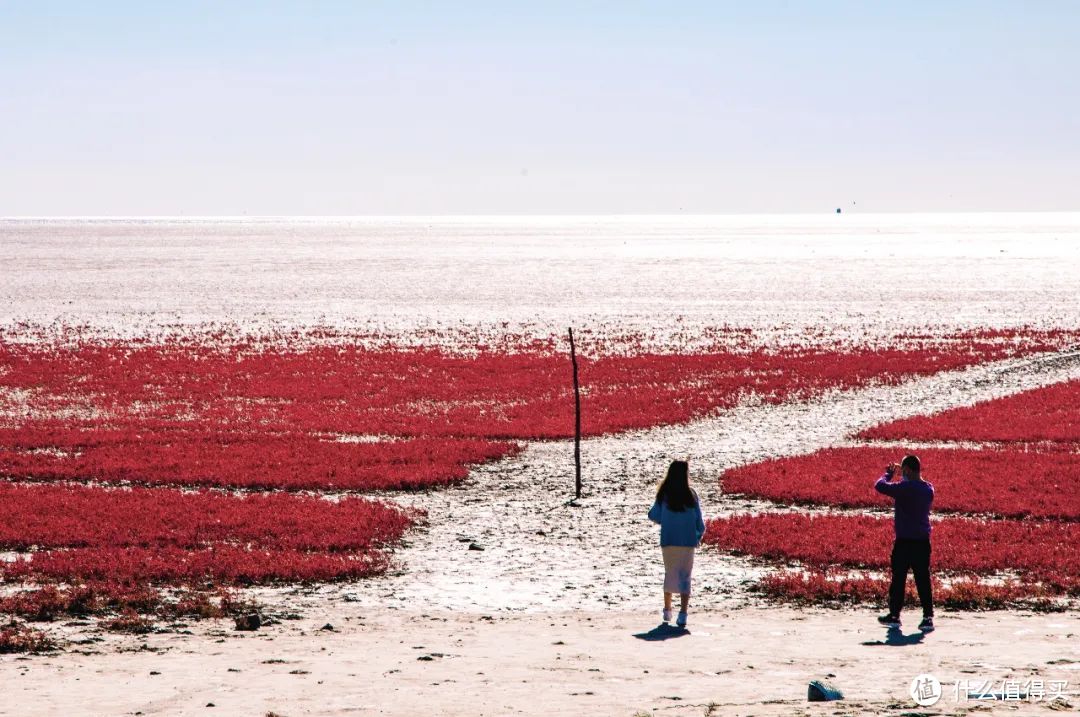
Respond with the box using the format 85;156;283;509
0;0;1080;216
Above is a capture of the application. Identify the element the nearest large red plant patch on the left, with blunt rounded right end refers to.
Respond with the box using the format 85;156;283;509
0;483;410;584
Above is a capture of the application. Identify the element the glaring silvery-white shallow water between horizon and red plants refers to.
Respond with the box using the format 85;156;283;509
0;214;1080;342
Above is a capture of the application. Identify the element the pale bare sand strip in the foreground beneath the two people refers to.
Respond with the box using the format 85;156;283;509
0;604;1080;717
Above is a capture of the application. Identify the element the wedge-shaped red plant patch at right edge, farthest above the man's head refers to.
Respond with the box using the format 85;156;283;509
860;381;1080;450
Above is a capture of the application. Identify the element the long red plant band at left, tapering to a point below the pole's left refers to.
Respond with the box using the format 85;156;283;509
0;427;517;490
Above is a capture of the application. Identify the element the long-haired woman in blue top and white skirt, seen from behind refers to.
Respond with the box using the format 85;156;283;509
649;461;705;627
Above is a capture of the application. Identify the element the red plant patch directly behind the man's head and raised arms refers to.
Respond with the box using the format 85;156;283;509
723;447;1080;520
